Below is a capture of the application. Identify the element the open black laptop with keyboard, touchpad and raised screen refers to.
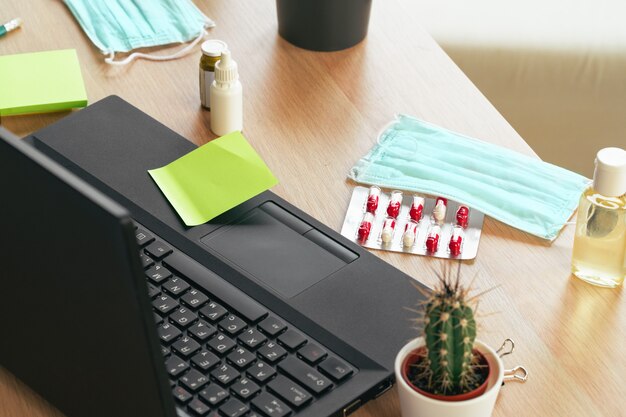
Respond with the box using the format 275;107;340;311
0;96;421;417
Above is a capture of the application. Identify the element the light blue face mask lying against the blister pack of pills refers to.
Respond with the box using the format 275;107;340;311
348;115;590;240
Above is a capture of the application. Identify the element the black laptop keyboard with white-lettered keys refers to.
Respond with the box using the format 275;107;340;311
135;227;356;417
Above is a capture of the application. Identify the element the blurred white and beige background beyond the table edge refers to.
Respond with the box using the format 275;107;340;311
416;0;626;177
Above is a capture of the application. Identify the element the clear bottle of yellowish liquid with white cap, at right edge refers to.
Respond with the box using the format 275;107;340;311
572;148;626;288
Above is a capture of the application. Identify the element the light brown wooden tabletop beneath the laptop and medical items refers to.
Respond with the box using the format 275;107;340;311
0;0;626;417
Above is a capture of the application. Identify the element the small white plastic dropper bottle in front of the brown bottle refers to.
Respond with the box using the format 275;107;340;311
210;50;243;136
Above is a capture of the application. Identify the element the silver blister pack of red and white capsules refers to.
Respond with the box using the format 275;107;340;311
341;186;485;259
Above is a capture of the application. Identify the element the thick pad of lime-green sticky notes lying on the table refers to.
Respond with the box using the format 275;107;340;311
0;49;87;116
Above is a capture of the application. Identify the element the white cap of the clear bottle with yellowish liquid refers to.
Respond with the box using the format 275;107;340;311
593;148;626;197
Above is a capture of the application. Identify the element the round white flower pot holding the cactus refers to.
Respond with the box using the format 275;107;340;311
394;337;504;417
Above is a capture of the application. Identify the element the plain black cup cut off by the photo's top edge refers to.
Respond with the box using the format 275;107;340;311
276;0;372;51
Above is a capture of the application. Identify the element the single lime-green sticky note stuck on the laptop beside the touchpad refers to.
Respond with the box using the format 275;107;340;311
148;132;278;226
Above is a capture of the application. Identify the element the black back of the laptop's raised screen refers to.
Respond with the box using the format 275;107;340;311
0;128;175;417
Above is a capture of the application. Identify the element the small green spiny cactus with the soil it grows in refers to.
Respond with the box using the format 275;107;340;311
411;264;484;395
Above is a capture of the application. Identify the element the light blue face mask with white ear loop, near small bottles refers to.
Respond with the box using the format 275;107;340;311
65;0;215;65
